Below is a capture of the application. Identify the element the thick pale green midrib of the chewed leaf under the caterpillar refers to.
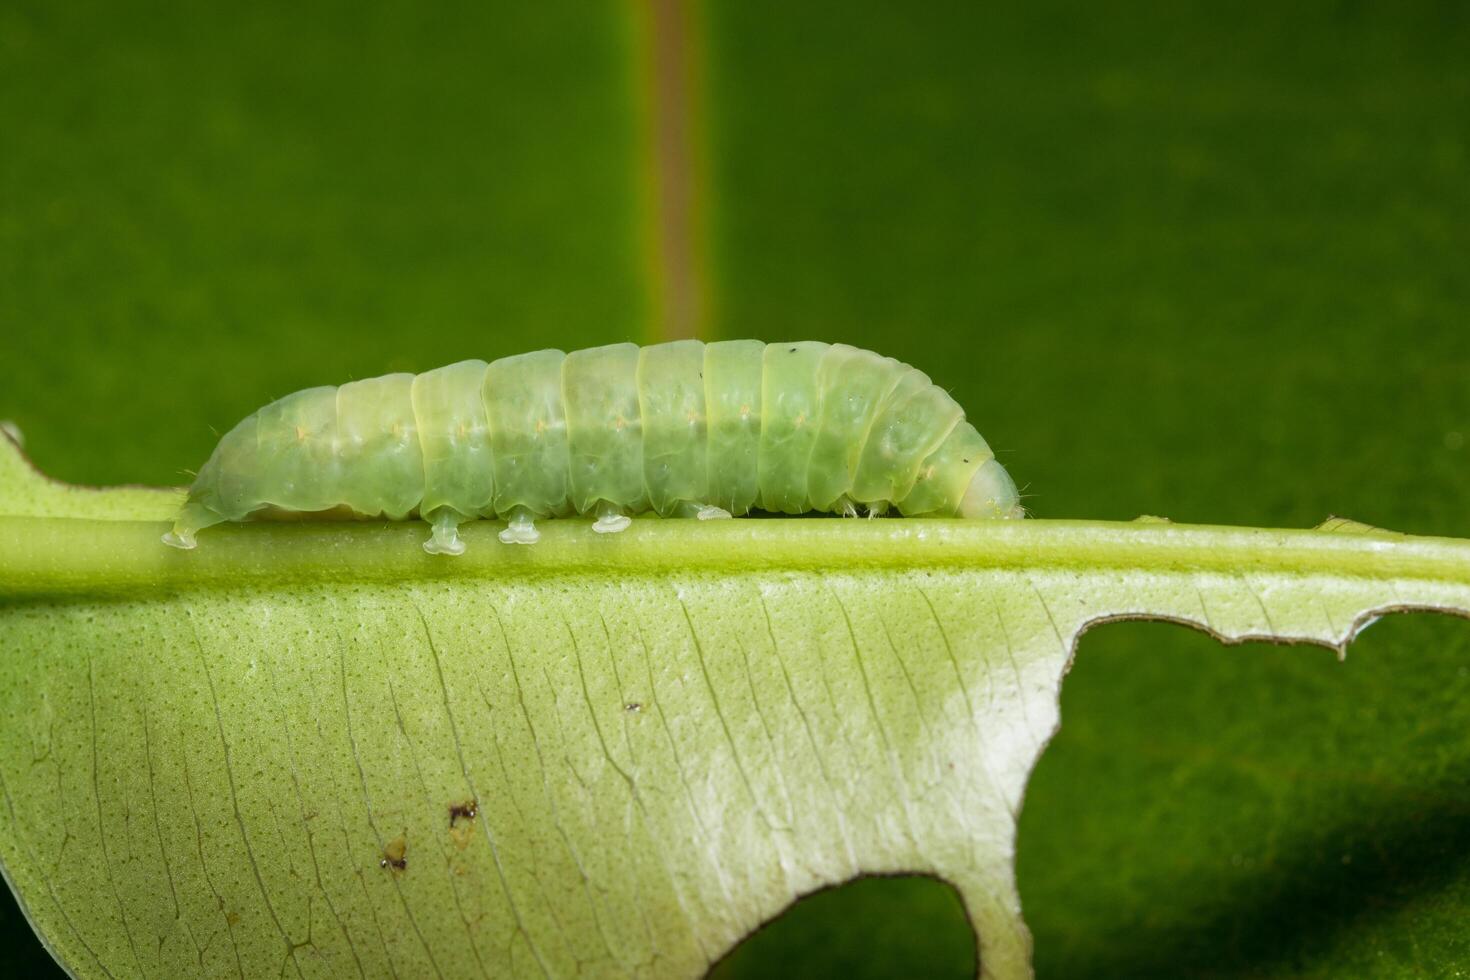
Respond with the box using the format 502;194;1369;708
0;517;1470;598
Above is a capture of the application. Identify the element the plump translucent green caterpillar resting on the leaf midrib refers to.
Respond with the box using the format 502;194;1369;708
163;341;1023;554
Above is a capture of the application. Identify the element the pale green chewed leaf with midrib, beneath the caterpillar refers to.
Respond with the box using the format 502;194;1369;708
0;442;1470;977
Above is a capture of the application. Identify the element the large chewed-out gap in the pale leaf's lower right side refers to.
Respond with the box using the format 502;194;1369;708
1017;614;1470;980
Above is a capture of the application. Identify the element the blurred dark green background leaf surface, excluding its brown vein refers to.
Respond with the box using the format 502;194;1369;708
0;0;1470;977
